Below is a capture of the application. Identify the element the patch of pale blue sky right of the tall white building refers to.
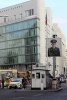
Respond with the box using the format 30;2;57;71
45;0;67;40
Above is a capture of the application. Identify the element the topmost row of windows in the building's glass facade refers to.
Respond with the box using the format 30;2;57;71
0;19;39;33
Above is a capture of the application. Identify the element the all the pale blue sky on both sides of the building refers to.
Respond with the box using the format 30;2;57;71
0;0;67;42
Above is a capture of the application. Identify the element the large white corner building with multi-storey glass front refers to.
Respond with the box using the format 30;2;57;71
0;0;46;71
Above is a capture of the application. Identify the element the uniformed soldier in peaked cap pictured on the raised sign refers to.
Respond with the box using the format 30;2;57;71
48;39;60;57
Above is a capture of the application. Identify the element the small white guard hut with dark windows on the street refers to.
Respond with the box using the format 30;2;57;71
31;66;49;90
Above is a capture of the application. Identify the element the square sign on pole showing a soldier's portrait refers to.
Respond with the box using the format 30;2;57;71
46;38;62;57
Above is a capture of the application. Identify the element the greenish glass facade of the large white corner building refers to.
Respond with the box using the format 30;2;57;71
0;19;40;65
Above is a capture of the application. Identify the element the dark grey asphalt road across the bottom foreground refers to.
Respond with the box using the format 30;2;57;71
0;83;67;100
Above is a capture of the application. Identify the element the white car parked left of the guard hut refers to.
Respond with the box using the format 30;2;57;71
8;78;22;89
